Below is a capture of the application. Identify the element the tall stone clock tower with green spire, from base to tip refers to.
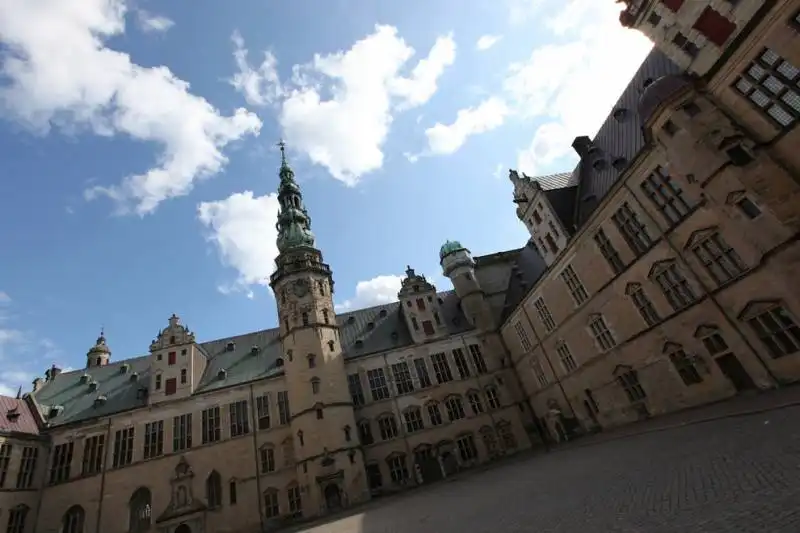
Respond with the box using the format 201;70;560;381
270;141;369;515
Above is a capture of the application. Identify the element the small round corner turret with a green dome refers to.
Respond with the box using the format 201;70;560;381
439;241;495;331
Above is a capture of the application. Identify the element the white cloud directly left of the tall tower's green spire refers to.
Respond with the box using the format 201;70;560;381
197;191;280;297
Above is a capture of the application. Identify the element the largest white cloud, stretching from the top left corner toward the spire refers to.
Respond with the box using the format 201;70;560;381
0;0;261;214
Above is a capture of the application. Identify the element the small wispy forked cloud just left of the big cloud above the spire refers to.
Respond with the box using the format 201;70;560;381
229;31;283;106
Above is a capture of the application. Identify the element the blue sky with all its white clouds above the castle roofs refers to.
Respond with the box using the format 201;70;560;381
0;0;652;394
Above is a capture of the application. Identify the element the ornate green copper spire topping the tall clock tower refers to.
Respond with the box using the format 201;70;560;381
277;141;314;252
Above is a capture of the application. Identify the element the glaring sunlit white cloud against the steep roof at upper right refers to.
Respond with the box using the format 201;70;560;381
504;0;652;174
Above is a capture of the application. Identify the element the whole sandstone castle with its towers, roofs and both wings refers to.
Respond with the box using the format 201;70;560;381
0;0;800;533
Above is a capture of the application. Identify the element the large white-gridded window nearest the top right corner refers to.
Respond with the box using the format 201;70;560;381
734;48;800;130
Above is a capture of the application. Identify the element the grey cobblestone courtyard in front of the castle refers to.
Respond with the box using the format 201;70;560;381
296;407;800;533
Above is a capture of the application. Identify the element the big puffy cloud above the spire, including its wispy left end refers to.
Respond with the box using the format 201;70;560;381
233;25;456;185
